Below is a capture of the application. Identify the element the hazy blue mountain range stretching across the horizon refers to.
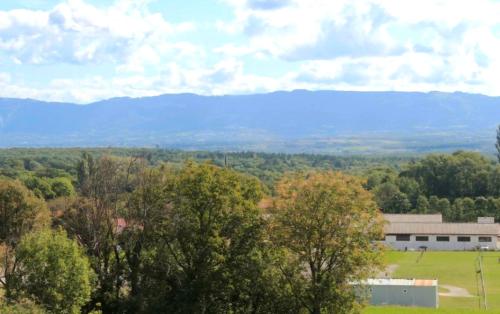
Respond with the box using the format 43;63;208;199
0;90;500;153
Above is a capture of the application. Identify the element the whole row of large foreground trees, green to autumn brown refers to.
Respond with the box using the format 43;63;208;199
0;154;383;314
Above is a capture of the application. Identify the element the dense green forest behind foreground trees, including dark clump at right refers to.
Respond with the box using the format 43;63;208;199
0;148;500;221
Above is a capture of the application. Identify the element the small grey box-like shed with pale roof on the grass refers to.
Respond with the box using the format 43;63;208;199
362;279;439;308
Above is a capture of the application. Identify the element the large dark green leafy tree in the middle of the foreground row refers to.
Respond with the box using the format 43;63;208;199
139;163;270;313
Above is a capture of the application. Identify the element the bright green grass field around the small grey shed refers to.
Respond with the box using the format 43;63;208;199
363;251;500;314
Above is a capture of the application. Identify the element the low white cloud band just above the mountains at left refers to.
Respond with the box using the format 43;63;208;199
0;60;293;104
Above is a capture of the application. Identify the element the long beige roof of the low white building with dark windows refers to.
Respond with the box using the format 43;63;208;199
384;222;499;236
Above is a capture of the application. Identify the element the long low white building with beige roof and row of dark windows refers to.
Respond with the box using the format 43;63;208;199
383;214;500;251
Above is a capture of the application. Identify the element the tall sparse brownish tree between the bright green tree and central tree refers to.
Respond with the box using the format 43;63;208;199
60;154;137;313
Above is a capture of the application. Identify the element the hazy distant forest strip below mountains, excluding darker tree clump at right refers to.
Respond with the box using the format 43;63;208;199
0;148;418;190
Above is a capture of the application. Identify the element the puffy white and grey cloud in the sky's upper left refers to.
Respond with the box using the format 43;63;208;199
0;0;198;70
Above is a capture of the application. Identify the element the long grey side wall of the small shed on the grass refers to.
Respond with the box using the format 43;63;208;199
368;285;439;308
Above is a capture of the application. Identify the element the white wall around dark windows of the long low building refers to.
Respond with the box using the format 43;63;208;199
382;234;497;251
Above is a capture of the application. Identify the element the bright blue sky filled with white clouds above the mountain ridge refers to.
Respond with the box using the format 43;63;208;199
0;0;500;104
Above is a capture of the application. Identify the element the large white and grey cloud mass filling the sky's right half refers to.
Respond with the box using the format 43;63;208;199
218;0;500;95
